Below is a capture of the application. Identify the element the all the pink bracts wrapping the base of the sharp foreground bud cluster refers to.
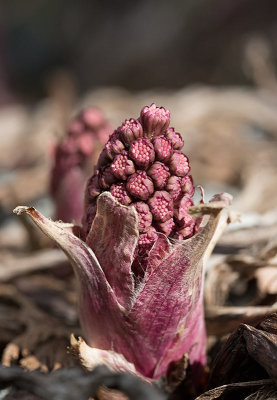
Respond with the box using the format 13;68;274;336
15;192;230;379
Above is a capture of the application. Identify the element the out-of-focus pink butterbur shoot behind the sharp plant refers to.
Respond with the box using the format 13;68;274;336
50;107;112;223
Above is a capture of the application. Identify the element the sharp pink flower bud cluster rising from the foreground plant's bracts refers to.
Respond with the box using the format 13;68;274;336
83;104;195;264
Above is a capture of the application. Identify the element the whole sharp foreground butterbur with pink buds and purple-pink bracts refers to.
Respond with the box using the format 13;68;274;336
15;104;231;386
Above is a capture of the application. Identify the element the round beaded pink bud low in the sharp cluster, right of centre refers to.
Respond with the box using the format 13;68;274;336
148;190;173;222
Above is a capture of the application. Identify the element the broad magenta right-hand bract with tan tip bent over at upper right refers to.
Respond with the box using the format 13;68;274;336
130;192;231;379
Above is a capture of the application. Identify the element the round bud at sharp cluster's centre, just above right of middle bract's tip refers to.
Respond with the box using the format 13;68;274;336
126;171;154;200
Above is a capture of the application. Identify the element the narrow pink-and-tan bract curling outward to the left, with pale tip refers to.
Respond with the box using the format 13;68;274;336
14;206;125;348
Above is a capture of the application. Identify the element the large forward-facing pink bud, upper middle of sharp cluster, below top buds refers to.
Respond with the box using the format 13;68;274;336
129;138;155;169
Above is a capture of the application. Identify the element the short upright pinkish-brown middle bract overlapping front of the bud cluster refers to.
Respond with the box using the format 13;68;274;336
86;192;139;307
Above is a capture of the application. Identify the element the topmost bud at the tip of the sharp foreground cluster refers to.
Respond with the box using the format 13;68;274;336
140;103;170;138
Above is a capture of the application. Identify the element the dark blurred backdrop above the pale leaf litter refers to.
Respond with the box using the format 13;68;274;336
1;0;277;96
